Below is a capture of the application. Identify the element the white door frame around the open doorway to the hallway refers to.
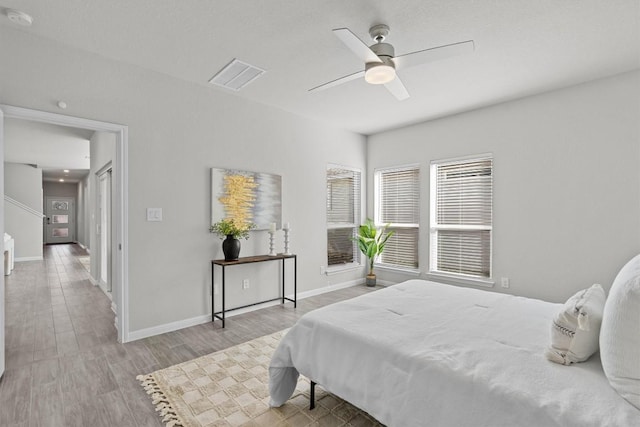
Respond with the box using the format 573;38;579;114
0;104;130;343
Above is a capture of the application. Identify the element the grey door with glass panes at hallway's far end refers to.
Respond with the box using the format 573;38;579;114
44;197;76;244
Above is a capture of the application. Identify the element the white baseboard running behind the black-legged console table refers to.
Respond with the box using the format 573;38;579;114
127;279;364;342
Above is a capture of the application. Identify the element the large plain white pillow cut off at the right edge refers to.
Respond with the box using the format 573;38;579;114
600;255;640;409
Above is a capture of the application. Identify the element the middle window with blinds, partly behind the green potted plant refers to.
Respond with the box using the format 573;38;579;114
375;166;420;269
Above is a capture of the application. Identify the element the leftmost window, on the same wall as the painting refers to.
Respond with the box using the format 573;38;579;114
327;165;361;267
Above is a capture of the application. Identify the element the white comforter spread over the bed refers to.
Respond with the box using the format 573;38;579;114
269;280;640;427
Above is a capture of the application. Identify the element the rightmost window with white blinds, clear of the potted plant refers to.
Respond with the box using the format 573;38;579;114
430;155;493;279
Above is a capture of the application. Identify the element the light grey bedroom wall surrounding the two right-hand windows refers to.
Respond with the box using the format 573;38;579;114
368;72;640;302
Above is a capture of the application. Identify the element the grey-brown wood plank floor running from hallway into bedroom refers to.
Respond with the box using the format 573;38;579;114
0;245;380;427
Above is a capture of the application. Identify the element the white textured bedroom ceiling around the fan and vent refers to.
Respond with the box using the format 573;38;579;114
0;0;640;134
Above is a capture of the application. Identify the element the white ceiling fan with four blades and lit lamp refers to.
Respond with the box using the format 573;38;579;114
309;24;474;101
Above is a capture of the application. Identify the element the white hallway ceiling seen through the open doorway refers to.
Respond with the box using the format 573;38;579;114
4;118;93;182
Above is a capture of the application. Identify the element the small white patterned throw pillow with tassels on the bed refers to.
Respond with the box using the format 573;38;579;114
545;284;606;365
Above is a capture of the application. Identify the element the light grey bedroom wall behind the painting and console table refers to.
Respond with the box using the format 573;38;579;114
0;26;366;331
